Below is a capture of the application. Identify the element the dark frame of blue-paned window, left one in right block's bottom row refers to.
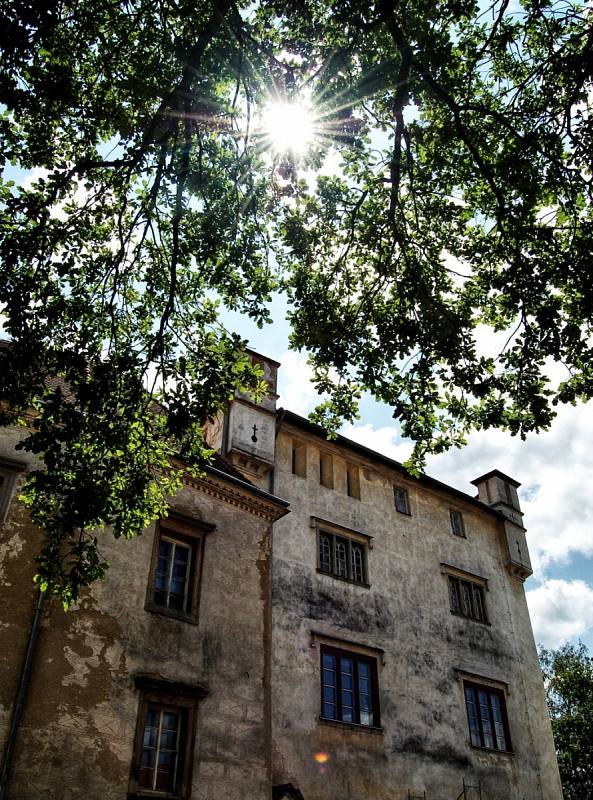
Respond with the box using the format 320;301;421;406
319;642;381;731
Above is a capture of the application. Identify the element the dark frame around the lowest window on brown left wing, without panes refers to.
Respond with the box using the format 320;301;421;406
128;675;208;800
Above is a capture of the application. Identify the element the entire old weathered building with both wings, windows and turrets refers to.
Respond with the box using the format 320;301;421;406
0;354;562;800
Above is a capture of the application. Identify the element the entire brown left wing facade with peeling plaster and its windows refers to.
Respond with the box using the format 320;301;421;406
0;422;286;800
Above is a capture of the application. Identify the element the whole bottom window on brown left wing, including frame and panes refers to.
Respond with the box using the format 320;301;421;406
129;675;207;798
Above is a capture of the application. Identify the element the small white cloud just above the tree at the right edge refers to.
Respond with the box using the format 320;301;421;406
526;580;593;648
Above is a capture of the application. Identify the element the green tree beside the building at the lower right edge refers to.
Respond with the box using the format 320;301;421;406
540;642;593;800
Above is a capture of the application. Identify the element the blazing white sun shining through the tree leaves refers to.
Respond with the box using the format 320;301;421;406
261;101;315;155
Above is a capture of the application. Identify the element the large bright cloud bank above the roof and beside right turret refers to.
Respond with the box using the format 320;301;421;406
338;402;593;578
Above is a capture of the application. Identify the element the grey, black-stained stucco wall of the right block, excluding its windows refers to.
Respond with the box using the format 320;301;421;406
273;426;561;800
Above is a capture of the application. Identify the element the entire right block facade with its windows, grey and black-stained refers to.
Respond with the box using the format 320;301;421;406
272;413;562;800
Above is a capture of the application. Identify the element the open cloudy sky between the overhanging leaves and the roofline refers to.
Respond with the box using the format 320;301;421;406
224;298;593;654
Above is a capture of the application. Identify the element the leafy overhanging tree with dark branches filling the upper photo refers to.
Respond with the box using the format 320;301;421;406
0;0;593;605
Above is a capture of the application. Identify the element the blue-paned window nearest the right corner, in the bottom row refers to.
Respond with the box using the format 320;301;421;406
464;683;511;752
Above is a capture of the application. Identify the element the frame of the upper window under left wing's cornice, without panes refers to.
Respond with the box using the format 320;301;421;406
144;513;216;624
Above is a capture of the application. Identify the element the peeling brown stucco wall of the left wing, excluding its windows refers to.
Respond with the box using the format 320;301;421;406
0;431;278;800
